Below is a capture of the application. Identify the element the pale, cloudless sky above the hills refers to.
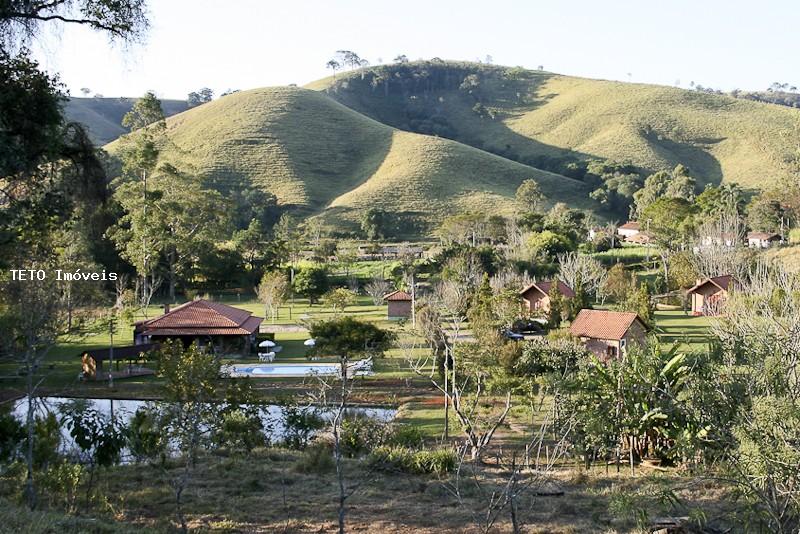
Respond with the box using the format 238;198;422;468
31;0;800;98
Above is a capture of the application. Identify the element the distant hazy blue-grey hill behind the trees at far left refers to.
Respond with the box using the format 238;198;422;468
64;98;188;146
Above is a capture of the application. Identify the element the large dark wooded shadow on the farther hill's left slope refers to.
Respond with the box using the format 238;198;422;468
326;62;593;178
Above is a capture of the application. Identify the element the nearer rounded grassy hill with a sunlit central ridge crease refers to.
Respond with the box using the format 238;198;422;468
109;87;590;233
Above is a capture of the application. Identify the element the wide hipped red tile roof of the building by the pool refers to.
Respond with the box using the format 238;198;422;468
136;299;263;335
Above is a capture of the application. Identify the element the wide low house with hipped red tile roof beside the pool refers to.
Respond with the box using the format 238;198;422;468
133;299;264;353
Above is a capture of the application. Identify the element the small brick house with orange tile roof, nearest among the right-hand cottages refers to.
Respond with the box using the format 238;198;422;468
569;310;648;361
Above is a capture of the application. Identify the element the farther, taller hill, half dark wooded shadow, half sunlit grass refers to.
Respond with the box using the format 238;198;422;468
308;61;800;191
